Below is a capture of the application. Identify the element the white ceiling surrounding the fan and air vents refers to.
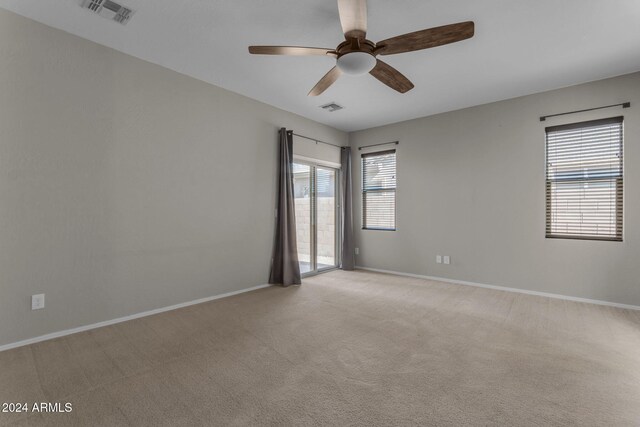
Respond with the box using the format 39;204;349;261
0;0;640;131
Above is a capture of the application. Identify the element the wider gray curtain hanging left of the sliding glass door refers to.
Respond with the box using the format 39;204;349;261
269;128;302;286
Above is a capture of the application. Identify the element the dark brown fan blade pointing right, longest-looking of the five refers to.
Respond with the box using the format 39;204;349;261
376;21;475;55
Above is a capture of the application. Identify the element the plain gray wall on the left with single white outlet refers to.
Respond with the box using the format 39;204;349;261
0;10;348;345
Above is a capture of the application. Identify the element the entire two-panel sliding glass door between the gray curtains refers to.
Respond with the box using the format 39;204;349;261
293;162;339;275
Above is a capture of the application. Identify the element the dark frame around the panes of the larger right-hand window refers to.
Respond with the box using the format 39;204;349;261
545;116;624;242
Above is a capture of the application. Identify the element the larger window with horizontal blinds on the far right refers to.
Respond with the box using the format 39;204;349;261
545;117;623;241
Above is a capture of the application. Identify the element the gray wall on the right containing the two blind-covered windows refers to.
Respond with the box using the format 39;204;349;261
350;73;640;305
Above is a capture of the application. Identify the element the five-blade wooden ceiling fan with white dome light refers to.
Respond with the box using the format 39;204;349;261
249;0;474;96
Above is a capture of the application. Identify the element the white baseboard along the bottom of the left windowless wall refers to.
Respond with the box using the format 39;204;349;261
0;285;271;352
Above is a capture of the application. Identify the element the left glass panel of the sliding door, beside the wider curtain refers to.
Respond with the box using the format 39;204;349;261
293;163;315;274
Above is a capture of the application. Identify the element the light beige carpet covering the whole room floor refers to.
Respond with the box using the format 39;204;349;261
0;271;640;426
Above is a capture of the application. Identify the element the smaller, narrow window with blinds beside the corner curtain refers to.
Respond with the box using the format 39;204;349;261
362;150;396;230
